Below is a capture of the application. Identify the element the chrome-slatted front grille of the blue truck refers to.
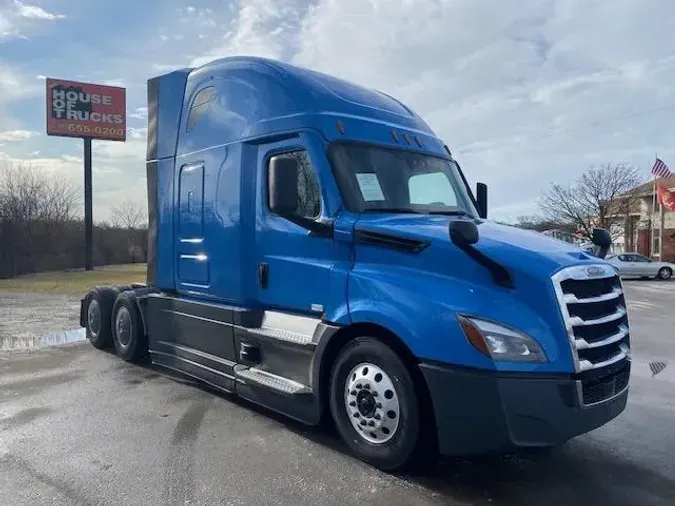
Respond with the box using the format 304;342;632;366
553;264;630;377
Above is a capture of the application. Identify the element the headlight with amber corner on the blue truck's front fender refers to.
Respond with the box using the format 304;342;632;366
457;316;548;363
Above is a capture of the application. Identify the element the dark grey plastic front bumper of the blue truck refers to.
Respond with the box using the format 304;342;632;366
420;360;630;456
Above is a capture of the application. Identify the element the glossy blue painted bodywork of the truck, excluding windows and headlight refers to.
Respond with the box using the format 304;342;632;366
148;57;616;380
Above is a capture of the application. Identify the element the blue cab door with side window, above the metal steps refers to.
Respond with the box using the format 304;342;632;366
255;132;345;315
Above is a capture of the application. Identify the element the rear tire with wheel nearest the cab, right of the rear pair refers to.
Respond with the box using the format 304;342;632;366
111;290;148;362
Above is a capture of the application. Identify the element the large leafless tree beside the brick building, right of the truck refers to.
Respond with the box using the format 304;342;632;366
539;163;643;237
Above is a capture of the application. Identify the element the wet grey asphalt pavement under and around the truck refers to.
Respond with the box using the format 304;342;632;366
0;281;675;506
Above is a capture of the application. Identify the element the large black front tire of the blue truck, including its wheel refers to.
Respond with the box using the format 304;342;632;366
329;337;422;471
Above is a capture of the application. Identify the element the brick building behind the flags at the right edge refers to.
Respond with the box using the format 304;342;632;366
616;176;675;262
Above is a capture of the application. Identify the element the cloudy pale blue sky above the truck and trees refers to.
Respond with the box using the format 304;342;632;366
0;0;675;221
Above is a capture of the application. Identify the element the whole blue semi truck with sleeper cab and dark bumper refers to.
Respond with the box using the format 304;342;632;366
80;57;631;470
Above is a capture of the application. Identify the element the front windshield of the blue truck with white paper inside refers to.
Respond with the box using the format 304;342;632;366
330;143;477;217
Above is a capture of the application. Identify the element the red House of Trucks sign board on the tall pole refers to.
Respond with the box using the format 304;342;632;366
47;78;127;141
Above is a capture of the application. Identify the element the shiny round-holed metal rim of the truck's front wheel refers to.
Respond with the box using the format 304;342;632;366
344;362;401;444
